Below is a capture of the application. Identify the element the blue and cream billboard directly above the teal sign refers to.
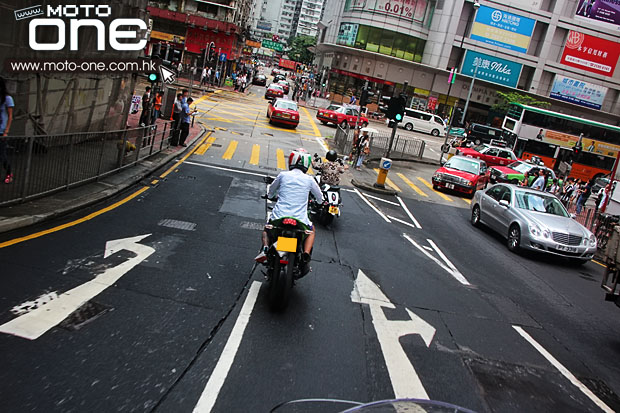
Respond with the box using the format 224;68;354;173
471;6;536;53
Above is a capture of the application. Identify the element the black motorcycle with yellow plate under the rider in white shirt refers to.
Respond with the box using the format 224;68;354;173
263;177;312;310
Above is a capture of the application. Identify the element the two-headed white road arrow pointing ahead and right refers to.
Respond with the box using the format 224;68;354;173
351;270;435;399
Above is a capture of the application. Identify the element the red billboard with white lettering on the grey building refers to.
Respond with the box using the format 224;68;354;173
560;30;620;76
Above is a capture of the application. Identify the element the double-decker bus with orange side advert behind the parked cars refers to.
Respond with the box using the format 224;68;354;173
502;103;620;180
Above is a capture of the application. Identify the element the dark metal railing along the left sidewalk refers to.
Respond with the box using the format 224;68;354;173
0;121;172;206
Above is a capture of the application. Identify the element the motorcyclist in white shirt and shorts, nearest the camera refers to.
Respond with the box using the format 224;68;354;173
255;149;323;264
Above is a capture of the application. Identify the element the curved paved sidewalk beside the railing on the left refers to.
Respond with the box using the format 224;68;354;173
0;112;207;233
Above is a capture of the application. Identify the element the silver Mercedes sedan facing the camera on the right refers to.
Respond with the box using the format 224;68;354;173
471;184;596;264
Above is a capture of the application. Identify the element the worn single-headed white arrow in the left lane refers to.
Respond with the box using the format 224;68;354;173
0;234;155;340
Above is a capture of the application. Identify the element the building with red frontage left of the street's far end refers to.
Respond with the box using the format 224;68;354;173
148;0;252;65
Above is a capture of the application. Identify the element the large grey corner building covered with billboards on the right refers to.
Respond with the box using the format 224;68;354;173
317;0;620;125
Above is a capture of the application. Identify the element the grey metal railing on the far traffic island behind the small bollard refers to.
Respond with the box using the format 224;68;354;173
334;126;426;160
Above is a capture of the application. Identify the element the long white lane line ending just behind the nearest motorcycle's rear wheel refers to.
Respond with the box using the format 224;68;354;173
193;281;261;413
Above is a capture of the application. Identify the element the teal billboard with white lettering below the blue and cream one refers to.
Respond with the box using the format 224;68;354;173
461;50;523;87
